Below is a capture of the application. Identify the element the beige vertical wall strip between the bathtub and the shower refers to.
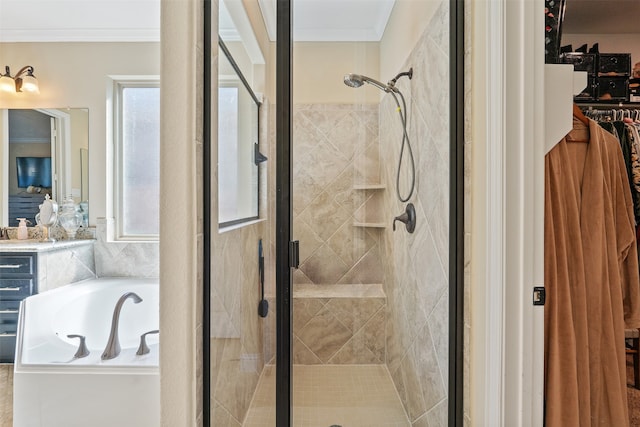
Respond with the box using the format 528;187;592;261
160;0;201;427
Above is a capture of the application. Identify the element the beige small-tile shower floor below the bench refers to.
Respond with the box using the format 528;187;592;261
243;365;410;427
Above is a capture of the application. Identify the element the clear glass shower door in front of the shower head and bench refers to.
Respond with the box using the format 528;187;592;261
278;1;459;427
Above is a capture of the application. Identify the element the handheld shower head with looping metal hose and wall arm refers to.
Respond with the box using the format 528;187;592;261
344;68;416;203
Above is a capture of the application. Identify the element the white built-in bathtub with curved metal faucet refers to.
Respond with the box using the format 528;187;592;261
13;278;160;427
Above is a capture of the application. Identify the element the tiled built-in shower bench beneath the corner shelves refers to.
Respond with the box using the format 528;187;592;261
293;284;387;365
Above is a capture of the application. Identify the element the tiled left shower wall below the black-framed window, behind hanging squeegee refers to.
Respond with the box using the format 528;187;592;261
210;102;276;427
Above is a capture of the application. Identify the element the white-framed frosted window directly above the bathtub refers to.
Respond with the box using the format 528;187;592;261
113;78;160;240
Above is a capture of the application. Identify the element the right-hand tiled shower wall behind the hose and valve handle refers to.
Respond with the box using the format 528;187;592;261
380;2;449;426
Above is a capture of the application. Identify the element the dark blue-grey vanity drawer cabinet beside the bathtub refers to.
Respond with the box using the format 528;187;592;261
0;252;38;363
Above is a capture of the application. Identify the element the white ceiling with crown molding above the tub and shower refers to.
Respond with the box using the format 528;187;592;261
0;0;395;42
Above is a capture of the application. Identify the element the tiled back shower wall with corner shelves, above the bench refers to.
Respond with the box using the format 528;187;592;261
293;104;382;284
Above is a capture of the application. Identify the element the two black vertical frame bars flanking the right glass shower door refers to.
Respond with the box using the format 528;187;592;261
276;0;464;427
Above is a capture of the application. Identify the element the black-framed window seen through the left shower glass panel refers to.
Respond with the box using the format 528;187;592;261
218;43;260;227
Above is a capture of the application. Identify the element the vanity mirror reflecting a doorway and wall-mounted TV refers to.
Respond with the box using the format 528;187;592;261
0;108;89;227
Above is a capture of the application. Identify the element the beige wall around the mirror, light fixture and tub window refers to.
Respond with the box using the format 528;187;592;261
0;43;159;225
